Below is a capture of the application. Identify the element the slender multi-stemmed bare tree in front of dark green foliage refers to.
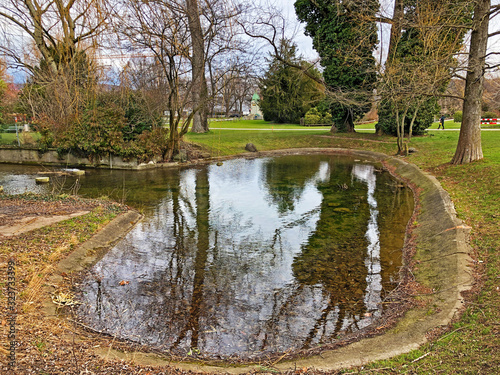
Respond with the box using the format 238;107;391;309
378;1;464;154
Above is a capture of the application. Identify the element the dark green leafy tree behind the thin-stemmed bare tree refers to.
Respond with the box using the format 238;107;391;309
376;0;471;135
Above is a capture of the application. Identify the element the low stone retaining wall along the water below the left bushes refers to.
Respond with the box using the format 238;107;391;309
0;147;156;169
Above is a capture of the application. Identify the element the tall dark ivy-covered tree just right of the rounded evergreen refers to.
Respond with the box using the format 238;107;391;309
295;0;379;131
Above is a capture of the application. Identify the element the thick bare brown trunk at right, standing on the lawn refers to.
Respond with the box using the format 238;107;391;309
451;0;491;164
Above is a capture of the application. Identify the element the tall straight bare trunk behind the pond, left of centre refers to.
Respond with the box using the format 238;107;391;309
186;0;208;133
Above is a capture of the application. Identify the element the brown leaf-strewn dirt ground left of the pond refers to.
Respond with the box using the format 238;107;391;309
0;195;330;375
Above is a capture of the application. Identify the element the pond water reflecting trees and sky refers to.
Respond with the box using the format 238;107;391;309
0;155;413;358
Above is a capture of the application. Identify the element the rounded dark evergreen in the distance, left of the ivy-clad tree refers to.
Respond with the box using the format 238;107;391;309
259;40;324;123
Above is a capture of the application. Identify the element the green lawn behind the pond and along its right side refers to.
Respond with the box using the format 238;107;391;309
187;121;500;374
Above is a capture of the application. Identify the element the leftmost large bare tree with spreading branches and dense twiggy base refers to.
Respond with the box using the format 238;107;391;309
0;0;108;153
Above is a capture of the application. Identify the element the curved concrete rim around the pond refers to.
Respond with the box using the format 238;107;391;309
45;148;473;374
